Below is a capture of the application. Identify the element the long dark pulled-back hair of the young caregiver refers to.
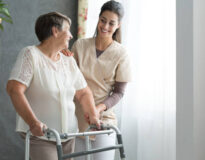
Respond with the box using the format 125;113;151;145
94;0;124;43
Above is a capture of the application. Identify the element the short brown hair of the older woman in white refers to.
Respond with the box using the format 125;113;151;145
35;12;71;42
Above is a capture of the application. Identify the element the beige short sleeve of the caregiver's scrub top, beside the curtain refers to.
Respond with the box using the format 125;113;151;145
115;54;132;82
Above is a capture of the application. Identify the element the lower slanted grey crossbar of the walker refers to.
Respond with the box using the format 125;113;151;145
60;145;122;159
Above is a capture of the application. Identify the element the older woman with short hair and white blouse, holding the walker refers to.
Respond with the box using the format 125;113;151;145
7;12;99;160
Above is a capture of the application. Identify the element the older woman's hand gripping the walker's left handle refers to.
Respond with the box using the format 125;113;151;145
30;121;47;136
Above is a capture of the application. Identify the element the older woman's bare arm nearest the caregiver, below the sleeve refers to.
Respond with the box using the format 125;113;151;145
75;87;100;129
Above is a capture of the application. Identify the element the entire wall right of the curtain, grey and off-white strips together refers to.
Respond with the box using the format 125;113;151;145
176;0;205;160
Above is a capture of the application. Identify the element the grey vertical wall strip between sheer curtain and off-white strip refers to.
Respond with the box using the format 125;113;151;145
176;0;194;160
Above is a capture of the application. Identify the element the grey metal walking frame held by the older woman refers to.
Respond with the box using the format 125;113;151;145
25;125;125;160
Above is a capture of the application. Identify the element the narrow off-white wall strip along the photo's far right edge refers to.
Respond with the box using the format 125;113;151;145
193;0;205;160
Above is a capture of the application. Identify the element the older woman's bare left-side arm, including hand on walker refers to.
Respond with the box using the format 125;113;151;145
7;80;46;136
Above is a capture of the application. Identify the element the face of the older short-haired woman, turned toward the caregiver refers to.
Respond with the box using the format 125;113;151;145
58;21;73;49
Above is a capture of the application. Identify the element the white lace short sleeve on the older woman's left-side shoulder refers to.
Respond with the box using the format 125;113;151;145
9;48;33;87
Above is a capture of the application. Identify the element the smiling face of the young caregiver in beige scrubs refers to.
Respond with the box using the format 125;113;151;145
97;11;120;38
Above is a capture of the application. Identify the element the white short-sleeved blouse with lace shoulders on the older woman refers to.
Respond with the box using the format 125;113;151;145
9;46;87;140
